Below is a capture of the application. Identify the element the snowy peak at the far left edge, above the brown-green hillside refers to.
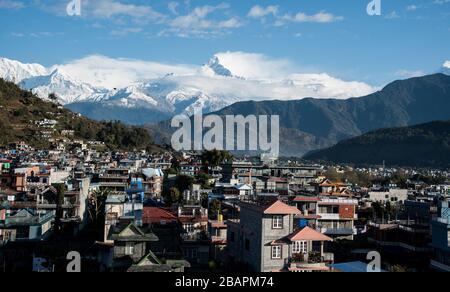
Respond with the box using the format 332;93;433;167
0;58;48;83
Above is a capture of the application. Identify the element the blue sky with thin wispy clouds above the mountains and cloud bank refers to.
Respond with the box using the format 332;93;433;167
0;0;450;86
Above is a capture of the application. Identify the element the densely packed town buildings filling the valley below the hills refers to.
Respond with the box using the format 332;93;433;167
0;139;450;272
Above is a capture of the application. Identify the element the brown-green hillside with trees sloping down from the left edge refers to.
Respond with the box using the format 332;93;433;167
0;79;160;150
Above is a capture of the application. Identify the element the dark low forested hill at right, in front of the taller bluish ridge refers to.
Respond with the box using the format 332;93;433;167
305;121;450;167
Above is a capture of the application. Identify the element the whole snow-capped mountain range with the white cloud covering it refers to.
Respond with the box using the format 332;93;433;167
5;52;444;124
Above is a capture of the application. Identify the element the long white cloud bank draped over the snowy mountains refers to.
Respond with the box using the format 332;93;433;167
52;52;375;101
